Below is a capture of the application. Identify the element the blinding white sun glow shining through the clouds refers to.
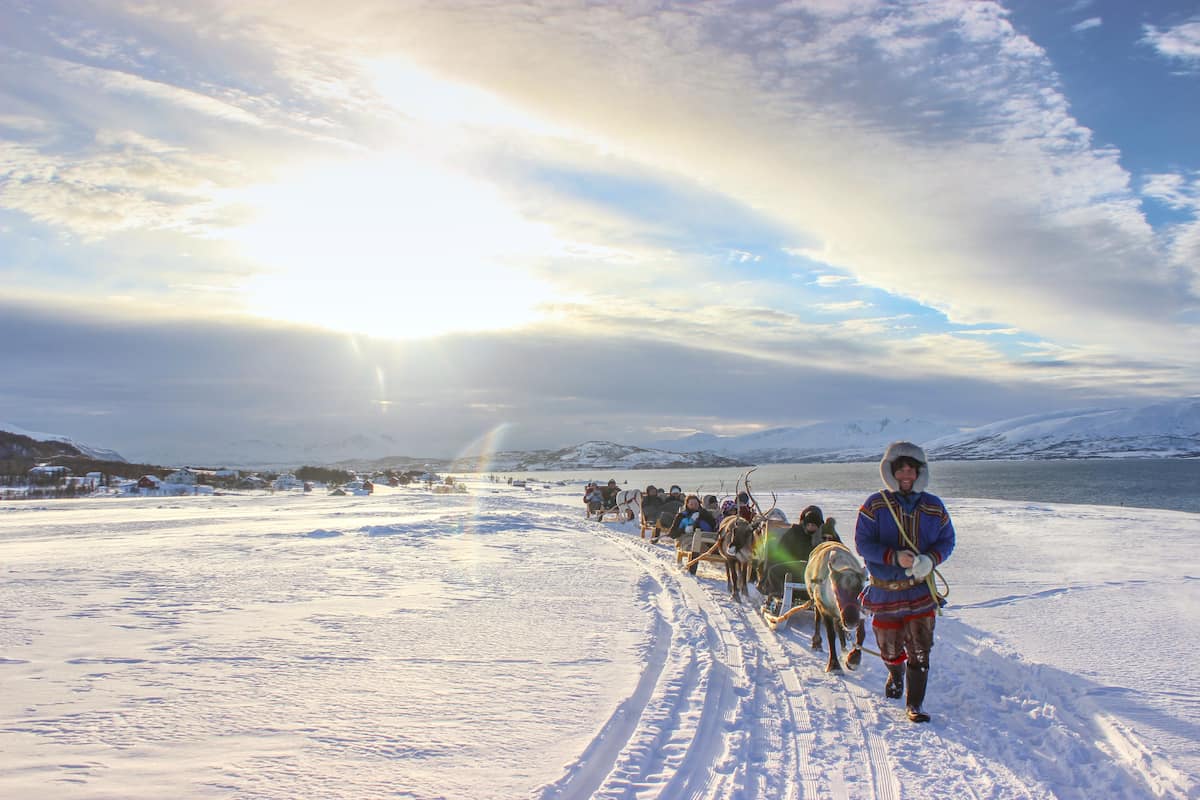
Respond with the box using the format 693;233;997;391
230;156;562;338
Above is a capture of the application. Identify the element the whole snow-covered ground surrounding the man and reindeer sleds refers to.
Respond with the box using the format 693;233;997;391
0;483;1200;800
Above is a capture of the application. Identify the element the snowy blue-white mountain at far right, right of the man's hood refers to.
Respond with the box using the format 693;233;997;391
922;397;1200;461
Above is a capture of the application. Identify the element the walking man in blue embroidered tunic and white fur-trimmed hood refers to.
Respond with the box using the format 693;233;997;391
854;441;954;722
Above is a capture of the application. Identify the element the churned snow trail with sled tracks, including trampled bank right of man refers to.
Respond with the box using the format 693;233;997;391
541;513;1196;800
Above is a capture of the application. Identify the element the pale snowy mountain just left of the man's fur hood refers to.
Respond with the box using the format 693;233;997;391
647;417;959;464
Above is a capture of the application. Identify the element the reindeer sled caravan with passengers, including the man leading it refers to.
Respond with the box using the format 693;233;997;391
588;441;955;722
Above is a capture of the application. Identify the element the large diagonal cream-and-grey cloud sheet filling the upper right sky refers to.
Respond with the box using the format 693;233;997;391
292;4;1193;347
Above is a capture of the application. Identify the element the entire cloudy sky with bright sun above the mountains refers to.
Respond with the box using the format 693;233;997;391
0;0;1200;462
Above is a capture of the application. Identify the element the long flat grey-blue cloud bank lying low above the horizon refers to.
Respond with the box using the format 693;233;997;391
0;298;1180;462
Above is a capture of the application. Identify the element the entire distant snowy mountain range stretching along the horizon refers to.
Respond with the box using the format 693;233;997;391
0;397;1200;471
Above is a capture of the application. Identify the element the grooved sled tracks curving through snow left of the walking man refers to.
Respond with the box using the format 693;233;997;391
541;521;1065;800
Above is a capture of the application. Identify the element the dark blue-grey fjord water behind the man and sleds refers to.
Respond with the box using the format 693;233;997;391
489;458;1200;512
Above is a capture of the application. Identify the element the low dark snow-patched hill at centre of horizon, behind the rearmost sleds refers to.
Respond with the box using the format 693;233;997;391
451;441;748;471
